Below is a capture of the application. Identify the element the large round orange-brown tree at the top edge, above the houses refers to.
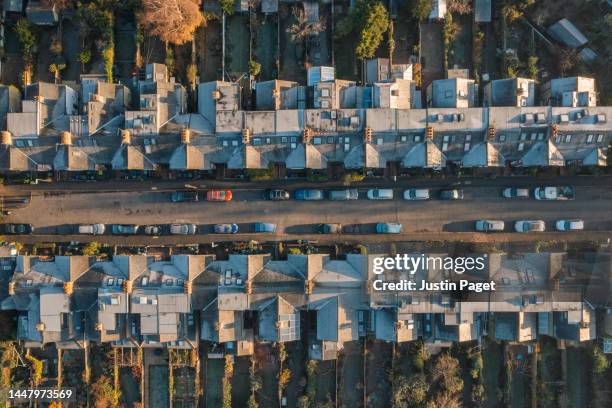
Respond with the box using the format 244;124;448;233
138;0;205;45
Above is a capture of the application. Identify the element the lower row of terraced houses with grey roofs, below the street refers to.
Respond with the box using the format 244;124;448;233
1;253;611;360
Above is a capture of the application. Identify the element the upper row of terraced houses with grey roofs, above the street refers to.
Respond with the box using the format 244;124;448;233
0;64;612;178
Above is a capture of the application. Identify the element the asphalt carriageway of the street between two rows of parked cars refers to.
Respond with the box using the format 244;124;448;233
4;181;612;240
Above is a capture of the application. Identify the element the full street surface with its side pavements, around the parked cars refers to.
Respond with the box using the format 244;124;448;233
3;177;612;244
